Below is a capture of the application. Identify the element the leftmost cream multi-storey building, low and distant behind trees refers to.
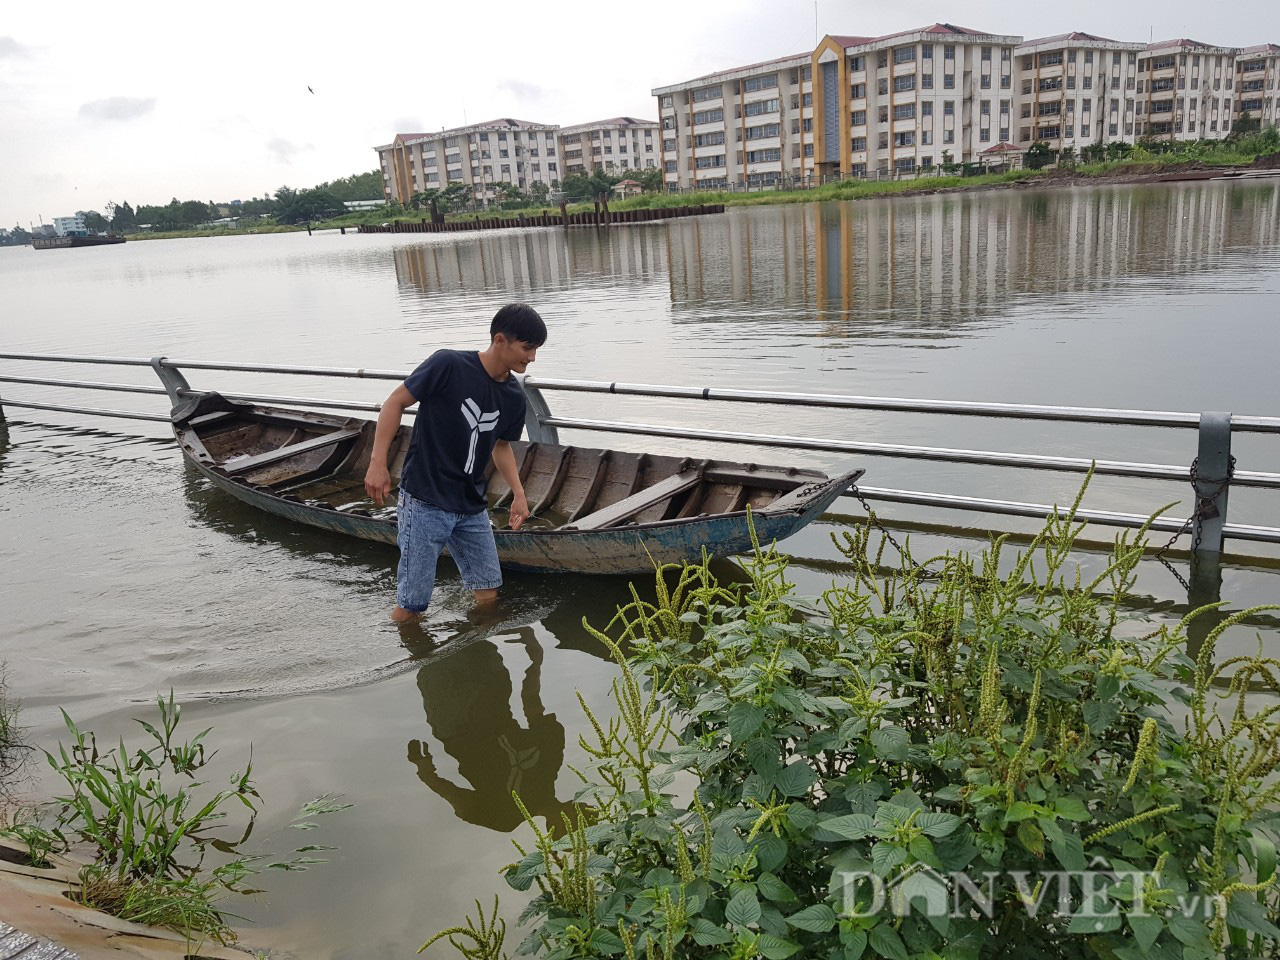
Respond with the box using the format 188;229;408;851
375;118;561;204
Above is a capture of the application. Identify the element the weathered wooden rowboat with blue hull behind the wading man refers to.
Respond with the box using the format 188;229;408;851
172;393;863;573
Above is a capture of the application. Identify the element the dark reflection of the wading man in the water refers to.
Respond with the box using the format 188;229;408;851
408;627;572;833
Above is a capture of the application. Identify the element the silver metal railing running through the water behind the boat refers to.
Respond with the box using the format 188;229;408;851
0;353;1280;554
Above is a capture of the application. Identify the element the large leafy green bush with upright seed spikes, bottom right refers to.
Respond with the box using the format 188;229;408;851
424;488;1280;960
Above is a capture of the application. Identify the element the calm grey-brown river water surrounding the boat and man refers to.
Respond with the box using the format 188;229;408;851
0;182;1280;957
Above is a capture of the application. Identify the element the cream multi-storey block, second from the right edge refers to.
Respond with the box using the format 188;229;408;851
1135;40;1240;140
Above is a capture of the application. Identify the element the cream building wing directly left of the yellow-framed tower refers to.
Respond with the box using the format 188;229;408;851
653;54;813;188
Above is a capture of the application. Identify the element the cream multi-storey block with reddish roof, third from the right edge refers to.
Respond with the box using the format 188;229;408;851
1014;32;1147;151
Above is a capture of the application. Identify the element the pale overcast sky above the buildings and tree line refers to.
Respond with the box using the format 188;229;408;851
0;0;1280;227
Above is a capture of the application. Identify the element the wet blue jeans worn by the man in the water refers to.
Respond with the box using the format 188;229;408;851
396;490;502;613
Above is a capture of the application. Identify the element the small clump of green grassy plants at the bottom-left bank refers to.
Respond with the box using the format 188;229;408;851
4;691;351;952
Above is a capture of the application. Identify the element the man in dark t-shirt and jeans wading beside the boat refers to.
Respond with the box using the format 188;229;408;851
365;303;547;623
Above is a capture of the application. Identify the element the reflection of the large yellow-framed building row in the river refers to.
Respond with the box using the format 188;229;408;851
668;184;1280;340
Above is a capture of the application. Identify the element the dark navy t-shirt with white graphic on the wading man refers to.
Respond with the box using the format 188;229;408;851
401;349;525;513
